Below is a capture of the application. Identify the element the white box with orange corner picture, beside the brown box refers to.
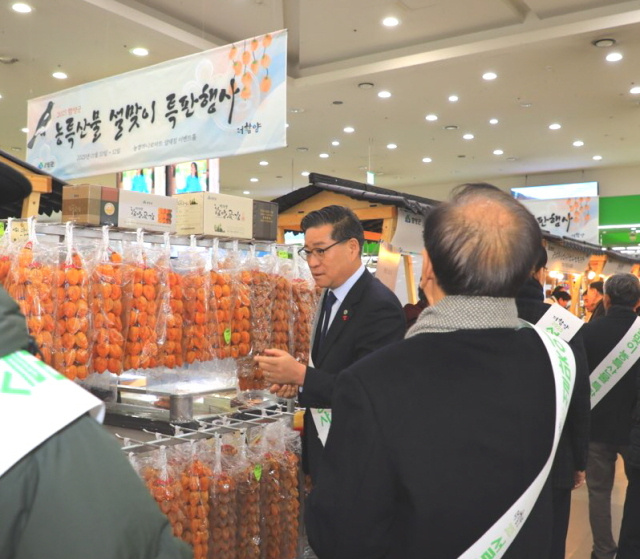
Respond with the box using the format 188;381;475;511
118;190;178;233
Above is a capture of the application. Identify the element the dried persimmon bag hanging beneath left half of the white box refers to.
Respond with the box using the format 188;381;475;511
123;229;166;371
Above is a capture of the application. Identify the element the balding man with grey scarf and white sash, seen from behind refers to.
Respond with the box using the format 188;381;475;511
306;184;575;559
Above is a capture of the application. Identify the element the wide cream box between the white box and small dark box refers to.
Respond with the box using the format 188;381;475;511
174;192;253;239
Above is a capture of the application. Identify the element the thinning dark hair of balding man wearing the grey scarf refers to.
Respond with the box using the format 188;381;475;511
424;183;542;297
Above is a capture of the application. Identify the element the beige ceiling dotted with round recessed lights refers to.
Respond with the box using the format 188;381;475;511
0;0;640;199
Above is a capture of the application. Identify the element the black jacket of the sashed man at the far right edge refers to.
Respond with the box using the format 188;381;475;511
582;305;640;445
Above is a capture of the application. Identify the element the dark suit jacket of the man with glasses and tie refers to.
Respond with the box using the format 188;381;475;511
299;270;406;480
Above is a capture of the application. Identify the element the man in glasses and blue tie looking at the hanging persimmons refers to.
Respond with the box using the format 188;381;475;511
256;206;405;482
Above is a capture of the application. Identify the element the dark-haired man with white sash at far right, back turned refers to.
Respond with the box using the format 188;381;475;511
582;274;640;559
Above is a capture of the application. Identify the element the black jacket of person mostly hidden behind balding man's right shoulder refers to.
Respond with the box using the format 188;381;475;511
516;278;591;489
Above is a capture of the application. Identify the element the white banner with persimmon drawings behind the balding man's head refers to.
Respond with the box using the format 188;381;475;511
520;196;600;244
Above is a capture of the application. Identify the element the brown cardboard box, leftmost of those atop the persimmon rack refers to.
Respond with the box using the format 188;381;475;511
62;184;119;227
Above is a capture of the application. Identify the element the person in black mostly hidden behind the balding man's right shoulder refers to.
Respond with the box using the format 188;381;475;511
516;245;591;559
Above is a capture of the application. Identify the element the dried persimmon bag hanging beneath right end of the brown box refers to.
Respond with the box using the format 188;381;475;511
90;226;125;375
